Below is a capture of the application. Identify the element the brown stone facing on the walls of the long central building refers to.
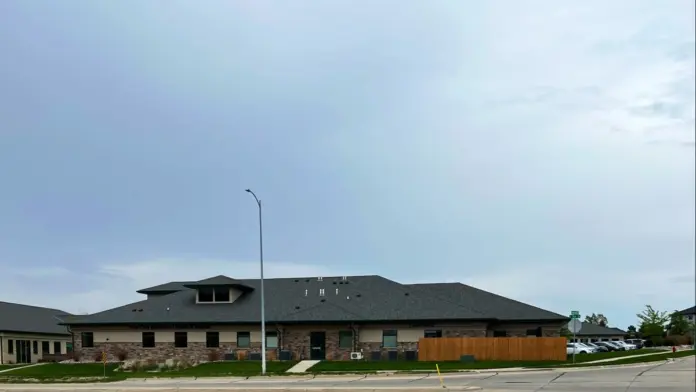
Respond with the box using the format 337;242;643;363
75;323;561;362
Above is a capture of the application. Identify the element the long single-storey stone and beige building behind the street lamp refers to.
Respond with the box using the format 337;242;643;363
65;276;568;360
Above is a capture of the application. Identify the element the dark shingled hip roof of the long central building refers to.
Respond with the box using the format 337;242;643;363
61;275;567;325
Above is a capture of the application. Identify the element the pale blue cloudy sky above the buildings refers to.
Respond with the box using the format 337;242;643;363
0;0;696;328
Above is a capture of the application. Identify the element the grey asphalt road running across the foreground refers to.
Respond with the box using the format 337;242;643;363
0;357;696;392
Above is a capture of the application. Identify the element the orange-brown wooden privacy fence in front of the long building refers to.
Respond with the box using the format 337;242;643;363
418;337;567;361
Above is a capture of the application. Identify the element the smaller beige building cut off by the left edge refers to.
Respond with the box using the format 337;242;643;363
0;302;72;364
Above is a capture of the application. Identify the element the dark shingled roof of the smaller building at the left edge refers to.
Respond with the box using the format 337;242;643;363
0;301;69;335
